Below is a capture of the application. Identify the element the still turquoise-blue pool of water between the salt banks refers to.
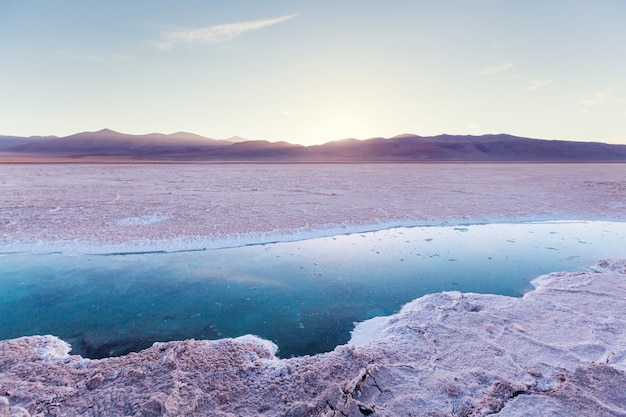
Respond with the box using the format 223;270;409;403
0;221;626;358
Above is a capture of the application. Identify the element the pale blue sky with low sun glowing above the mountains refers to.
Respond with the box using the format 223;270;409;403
0;0;626;145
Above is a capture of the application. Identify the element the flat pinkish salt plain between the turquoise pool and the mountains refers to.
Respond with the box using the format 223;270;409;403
0;164;626;250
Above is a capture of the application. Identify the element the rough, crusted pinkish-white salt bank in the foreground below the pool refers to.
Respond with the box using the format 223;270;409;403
0;260;626;417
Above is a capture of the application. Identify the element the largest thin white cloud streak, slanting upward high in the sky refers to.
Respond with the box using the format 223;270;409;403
155;14;297;50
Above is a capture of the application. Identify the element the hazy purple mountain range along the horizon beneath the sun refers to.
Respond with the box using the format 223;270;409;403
0;129;626;162
